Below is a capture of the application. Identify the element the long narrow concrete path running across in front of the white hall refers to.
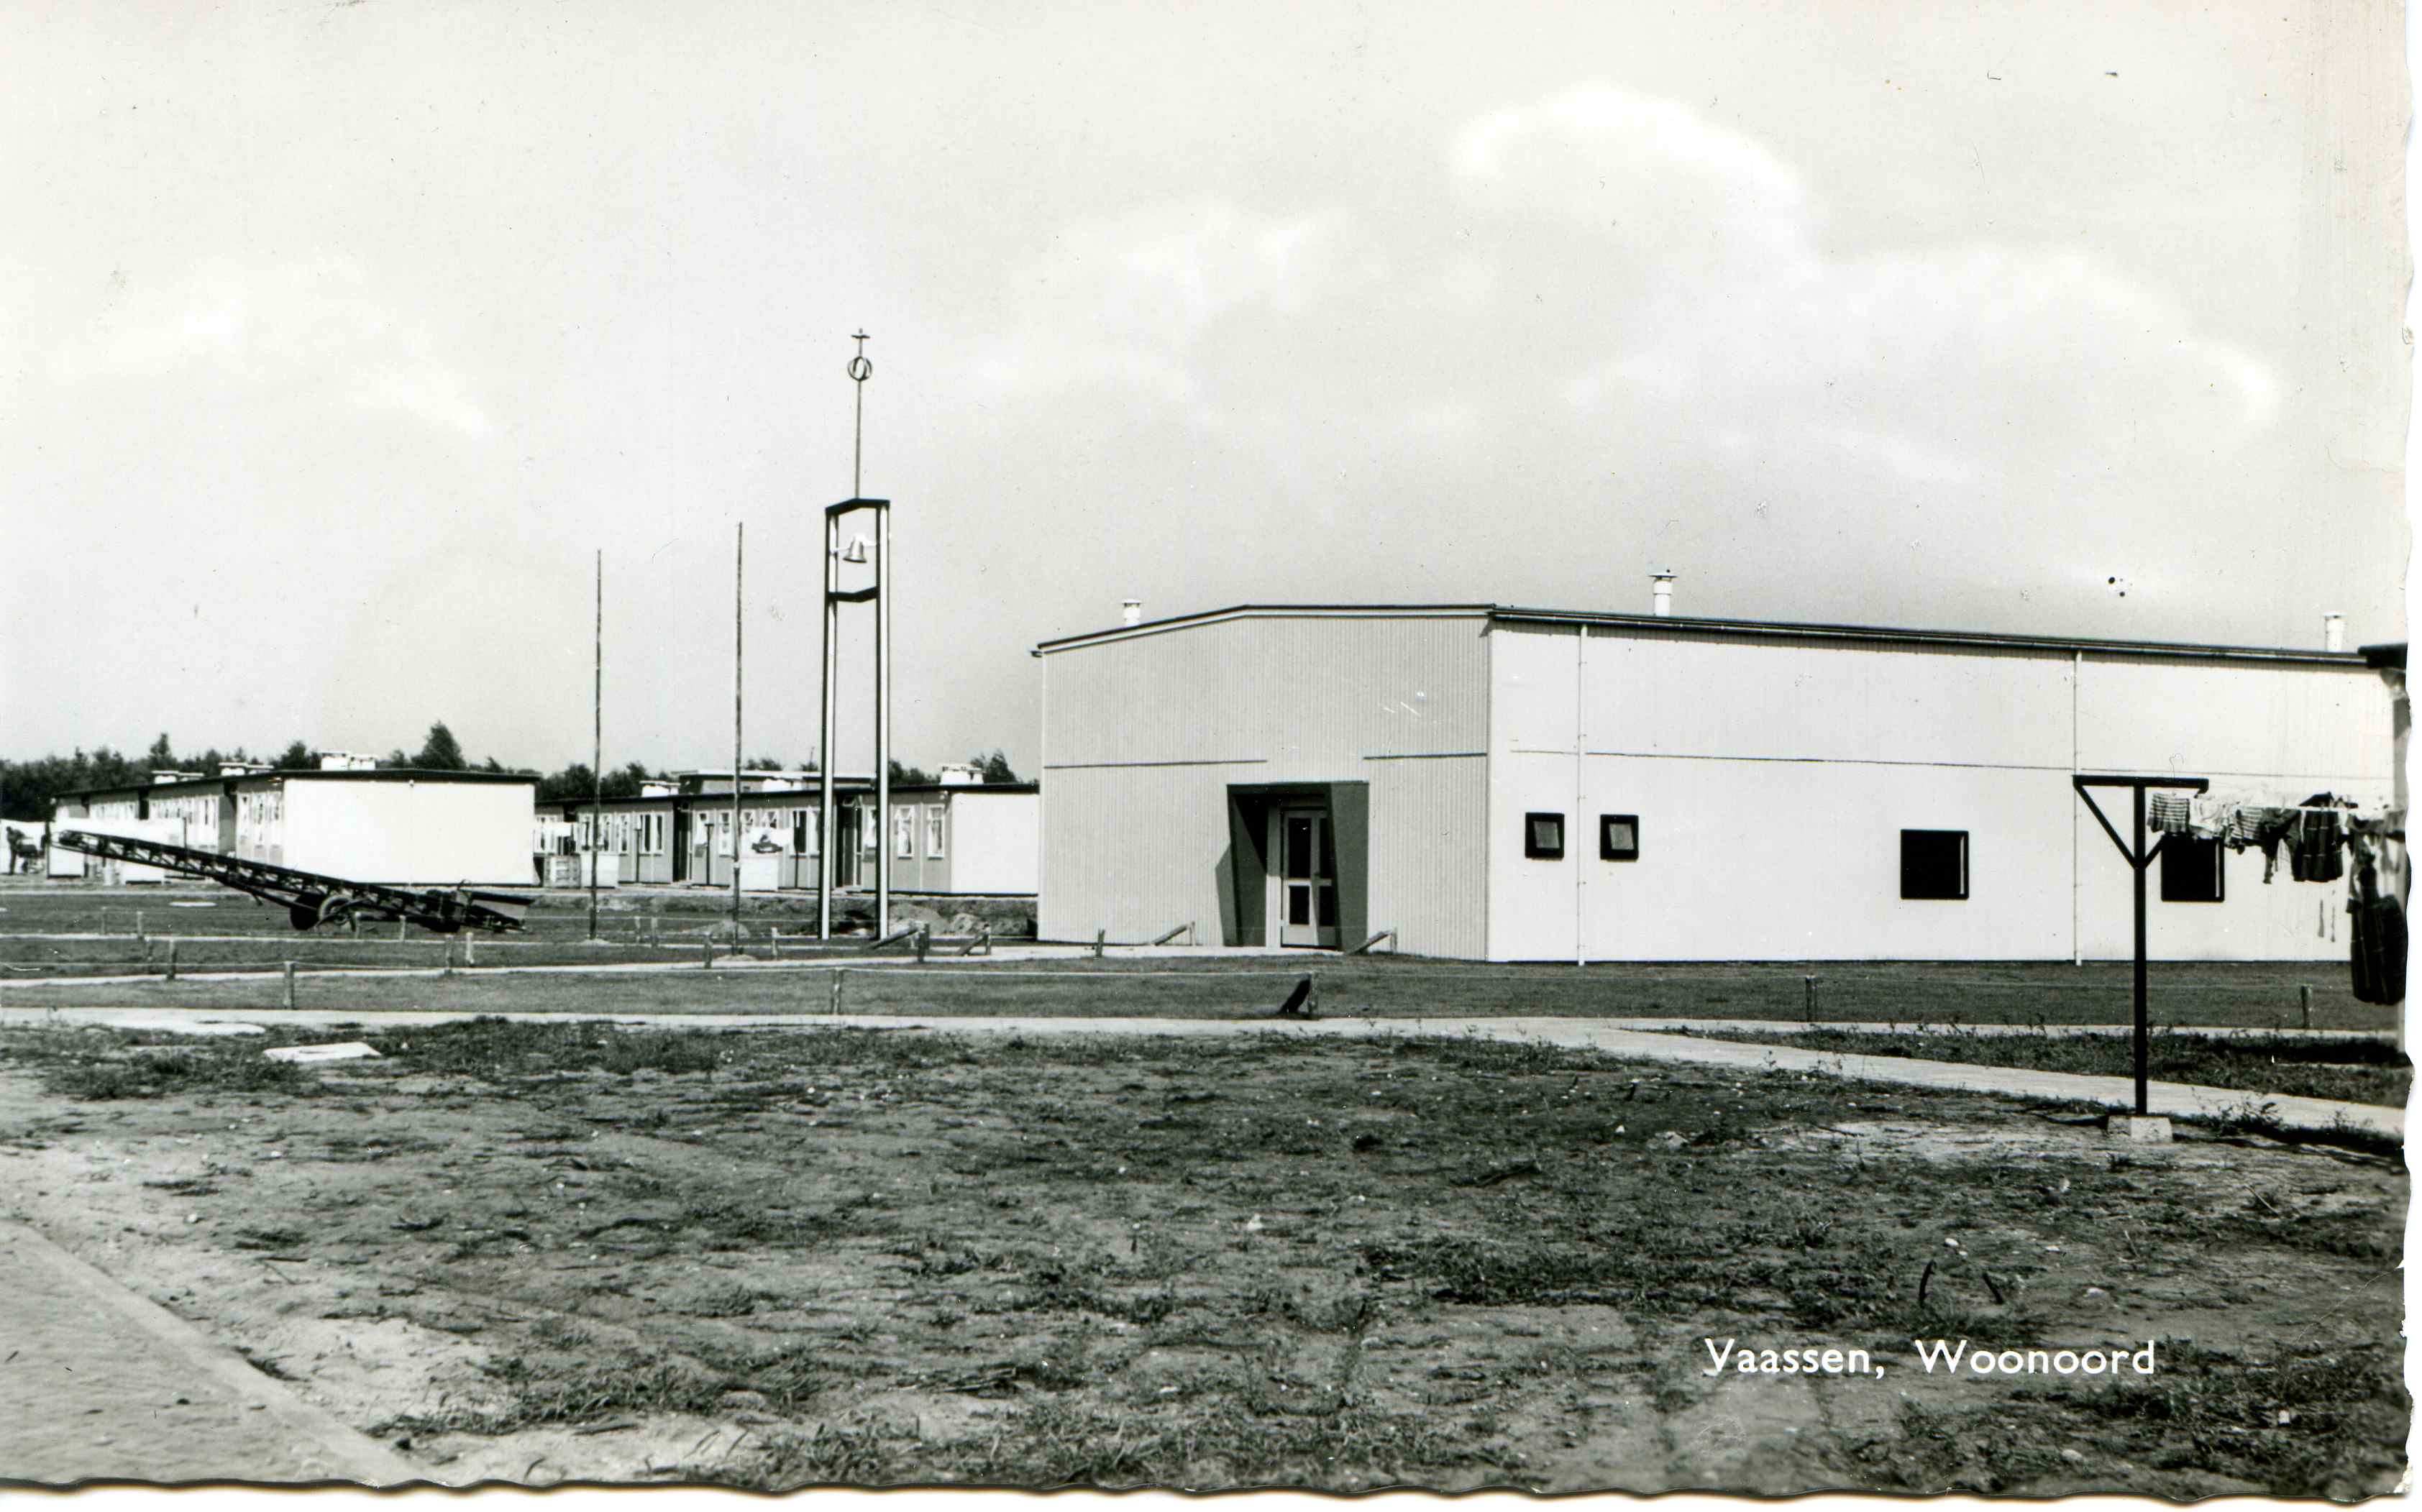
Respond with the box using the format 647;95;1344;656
0;1008;2405;1139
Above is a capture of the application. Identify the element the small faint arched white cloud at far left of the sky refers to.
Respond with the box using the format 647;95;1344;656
51;257;489;436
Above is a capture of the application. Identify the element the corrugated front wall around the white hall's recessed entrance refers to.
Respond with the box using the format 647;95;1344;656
1039;613;1487;950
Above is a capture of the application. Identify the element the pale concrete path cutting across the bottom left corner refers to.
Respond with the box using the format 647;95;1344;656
0;1222;429;1485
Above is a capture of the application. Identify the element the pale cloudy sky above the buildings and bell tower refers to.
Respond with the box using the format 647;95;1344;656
0;0;2410;771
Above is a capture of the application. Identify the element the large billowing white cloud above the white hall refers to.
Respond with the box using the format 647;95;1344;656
976;85;2282;538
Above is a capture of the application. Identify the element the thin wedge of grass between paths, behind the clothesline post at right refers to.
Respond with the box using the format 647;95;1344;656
1703;1025;2413;1107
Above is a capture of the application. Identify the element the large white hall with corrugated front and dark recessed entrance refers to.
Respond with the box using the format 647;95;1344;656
1037;606;2393;962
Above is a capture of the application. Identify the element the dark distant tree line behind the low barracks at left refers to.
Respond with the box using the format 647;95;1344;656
0;720;1018;821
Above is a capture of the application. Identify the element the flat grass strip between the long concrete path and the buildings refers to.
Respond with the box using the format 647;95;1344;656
0;889;2395;1030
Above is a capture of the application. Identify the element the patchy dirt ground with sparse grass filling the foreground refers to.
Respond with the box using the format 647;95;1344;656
0;1020;2410;1498
